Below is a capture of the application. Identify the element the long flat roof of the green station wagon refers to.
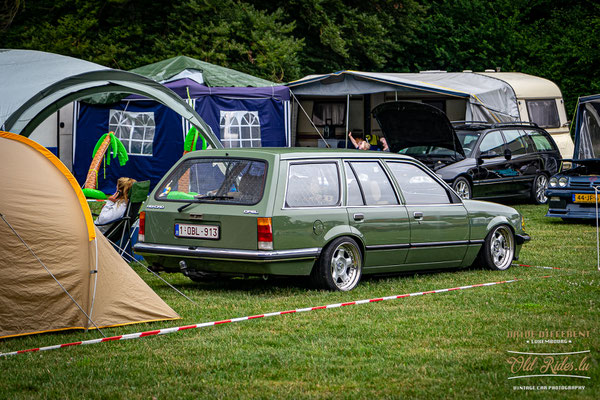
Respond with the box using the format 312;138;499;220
188;147;414;161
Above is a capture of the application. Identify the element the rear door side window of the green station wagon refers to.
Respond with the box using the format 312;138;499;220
350;161;398;206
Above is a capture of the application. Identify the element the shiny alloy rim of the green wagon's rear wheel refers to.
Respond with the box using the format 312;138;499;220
331;242;362;291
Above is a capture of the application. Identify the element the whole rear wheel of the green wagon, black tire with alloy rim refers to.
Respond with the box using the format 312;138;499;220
311;236;363;292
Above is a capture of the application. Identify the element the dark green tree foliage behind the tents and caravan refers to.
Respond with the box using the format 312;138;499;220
0;0;600;112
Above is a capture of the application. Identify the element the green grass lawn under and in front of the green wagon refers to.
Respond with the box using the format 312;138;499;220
0;205;600;399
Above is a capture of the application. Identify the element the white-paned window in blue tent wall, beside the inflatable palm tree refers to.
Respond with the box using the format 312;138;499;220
108;110;156;156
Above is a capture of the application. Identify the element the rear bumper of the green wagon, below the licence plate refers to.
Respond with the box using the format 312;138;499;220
133;243;321;262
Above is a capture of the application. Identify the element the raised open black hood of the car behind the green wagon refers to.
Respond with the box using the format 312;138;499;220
373;101;465;157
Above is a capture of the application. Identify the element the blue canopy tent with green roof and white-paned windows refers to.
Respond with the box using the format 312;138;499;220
73;56;290;192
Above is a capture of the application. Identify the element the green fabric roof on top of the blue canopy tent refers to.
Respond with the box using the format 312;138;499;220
130;56;277;87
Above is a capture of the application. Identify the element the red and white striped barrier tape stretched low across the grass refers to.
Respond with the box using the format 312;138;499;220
0;276;550;357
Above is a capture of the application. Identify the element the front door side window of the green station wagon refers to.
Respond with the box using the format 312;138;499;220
387;162;451;205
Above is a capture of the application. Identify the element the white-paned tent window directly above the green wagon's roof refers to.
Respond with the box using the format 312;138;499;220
219;111;262;148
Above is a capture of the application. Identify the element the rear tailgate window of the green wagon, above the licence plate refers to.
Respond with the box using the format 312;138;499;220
155;158;267;205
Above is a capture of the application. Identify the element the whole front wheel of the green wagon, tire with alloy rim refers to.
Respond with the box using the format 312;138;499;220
479;225;515;271
